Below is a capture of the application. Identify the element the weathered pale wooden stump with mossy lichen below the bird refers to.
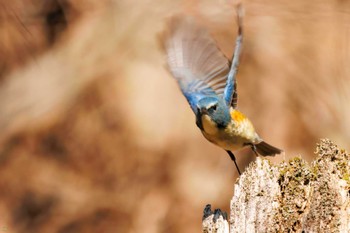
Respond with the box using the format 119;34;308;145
203;139;350;233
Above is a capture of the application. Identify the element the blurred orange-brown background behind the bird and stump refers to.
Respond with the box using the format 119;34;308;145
0;0;350;233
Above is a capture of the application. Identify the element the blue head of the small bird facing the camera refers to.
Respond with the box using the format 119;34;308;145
196;97;231;130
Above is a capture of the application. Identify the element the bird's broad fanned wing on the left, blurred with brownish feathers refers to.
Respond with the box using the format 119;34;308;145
165;18;230;113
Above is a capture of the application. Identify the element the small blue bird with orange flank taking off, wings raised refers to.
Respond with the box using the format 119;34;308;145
164;6;283;175
